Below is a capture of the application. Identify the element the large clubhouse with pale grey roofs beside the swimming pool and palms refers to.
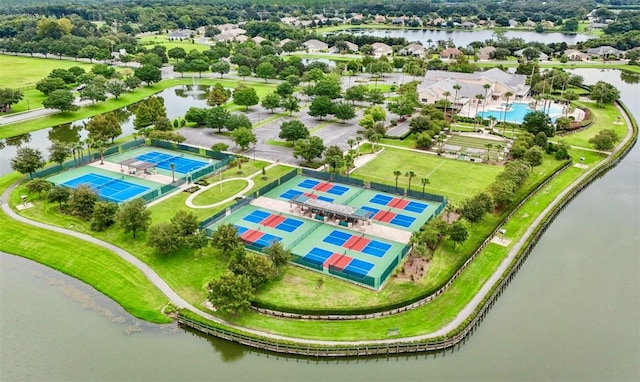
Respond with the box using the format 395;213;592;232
417;68;530;109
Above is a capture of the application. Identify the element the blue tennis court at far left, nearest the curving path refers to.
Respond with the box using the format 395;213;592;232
62;173;149;203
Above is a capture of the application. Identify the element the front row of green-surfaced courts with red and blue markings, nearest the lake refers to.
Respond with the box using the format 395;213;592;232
206;205;407;289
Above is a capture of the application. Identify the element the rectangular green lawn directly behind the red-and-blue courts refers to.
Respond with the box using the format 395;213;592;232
352;148;502;204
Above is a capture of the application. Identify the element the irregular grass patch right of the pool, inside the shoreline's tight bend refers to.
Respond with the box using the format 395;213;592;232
552;102;627;149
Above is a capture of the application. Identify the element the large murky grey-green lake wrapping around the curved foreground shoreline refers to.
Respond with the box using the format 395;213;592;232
0;70;640;381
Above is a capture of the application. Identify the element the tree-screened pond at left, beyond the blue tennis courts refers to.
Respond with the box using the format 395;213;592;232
0;85;207;175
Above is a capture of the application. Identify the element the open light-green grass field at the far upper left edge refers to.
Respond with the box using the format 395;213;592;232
0;54;94;89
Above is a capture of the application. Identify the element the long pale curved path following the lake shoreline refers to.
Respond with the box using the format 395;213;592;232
0;105;633;345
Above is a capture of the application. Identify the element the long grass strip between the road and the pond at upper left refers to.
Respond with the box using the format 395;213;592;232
0;76;275;139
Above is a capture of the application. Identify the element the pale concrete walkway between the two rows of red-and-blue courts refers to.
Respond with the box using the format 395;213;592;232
251;196;411;244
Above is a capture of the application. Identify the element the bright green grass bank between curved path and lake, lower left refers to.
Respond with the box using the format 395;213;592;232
0;173;170;323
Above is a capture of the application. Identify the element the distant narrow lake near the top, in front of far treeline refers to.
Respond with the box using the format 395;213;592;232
340;29;593;46
